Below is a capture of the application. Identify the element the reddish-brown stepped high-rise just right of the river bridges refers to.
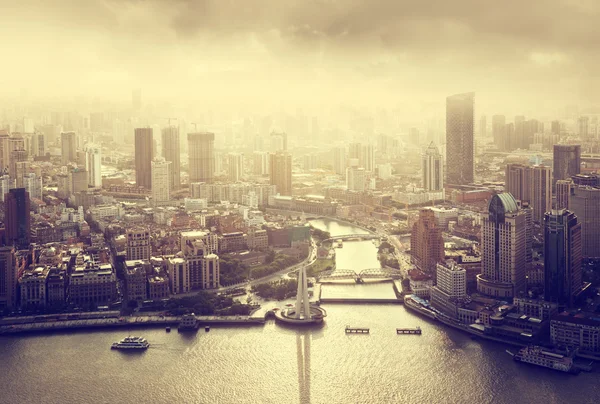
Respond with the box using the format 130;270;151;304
410;209;444;278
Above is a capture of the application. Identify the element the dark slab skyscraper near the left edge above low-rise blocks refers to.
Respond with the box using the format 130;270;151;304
4;188;31;249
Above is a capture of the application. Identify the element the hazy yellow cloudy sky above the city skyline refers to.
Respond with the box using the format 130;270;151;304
0;0;600;113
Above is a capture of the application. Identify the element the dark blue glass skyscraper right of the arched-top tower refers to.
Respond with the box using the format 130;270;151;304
544;209;582;306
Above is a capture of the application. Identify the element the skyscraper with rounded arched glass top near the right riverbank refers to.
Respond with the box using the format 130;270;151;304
477;192;527;298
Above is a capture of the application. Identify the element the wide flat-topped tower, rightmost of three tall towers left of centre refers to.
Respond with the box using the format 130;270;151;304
188;132;215;183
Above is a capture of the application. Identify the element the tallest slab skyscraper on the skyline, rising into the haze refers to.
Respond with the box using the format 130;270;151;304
446;93;475;185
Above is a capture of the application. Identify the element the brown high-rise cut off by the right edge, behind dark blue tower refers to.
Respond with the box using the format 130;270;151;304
569;186;600;258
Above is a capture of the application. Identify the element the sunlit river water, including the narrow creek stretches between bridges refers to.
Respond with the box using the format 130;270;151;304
0;221;600;404
